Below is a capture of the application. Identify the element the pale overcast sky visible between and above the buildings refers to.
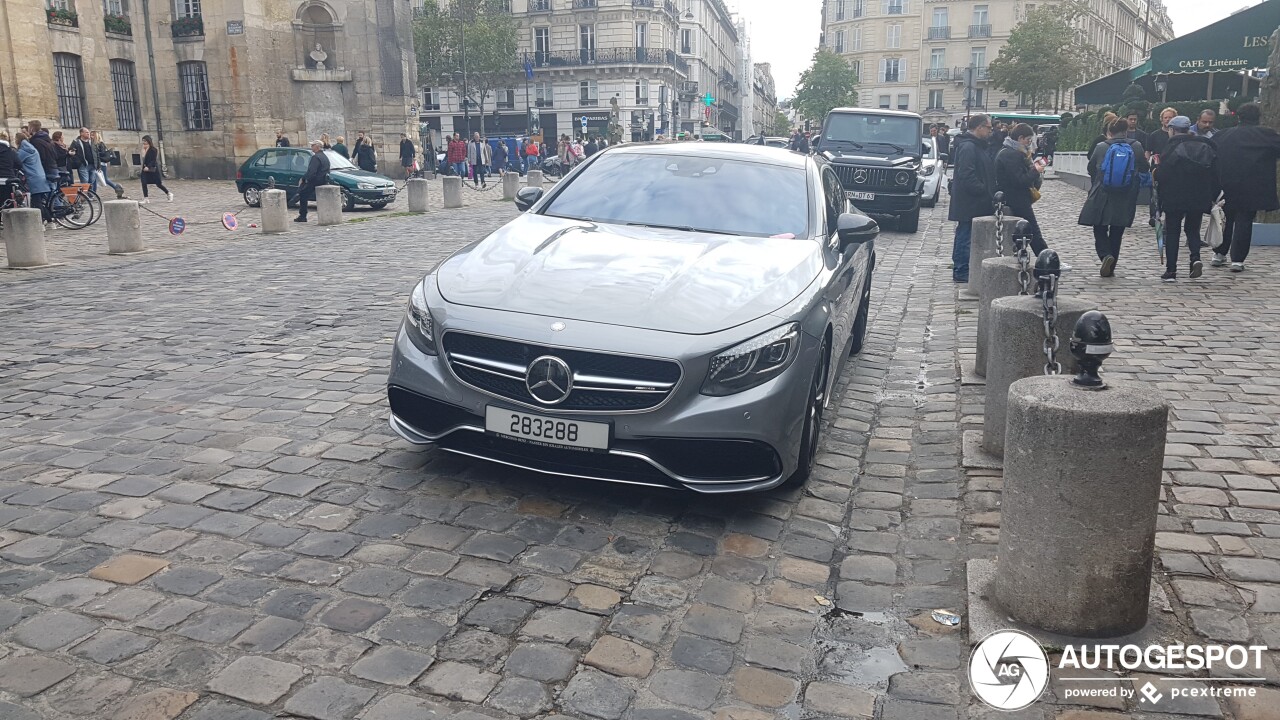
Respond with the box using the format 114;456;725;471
726;0;1257;99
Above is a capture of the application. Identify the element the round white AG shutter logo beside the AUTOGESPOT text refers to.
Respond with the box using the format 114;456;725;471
969;630;1048;710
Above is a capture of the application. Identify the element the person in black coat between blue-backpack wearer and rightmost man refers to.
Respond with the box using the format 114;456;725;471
1155;115;1219;282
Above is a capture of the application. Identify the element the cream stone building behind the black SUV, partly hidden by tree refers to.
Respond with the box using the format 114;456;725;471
822;0;1174;123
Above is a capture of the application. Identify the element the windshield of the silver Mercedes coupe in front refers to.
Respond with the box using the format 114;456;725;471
543;152;809;237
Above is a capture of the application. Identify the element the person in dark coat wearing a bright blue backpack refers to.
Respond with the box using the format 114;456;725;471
1079;118;1151;278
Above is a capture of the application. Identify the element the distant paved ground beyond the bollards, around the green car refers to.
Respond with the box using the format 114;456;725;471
0;179;519;283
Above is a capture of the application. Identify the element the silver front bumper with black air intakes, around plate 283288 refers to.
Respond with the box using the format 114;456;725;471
388;309;818;493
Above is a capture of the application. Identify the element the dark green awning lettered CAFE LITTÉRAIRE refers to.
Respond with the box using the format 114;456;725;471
1152;0;1280;78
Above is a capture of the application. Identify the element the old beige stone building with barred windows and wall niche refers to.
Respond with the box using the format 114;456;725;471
0;0;417;178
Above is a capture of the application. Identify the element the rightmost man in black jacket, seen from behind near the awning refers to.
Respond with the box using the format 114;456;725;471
1213;102;1280;273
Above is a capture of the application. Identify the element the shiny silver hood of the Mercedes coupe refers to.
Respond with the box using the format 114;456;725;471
436;213;823;334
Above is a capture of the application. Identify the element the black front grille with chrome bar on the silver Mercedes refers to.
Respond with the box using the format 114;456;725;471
443;332;680;413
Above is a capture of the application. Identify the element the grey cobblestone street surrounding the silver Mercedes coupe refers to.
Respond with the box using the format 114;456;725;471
0;178;1280;720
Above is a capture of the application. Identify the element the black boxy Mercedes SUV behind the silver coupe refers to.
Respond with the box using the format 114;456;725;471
815;108;923;232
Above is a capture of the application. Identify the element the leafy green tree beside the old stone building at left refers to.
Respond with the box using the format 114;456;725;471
413;0;522;134
